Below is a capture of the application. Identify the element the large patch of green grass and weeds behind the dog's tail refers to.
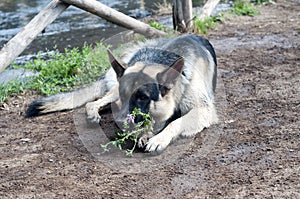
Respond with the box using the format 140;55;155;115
0;43;110;105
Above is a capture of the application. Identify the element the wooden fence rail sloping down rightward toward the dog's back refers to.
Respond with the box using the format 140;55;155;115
62;0;166;37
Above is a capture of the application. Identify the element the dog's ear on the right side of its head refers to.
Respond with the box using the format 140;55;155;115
156;57;184;96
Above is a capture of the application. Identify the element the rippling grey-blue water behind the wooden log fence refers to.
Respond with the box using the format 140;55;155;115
0;0;168;55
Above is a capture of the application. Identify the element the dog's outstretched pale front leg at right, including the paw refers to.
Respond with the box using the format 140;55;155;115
146;105;218;153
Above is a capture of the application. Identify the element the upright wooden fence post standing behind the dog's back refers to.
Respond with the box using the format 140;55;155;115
173;0;193;32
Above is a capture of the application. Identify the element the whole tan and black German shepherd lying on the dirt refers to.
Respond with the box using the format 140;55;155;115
26;34;218;153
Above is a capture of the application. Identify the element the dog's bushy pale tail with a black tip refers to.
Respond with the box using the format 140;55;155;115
25;79;107;117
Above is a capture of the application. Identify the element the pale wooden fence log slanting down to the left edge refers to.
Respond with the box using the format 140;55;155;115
0;0;69;73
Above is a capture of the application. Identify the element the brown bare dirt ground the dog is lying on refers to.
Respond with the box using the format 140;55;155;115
0;0;300;198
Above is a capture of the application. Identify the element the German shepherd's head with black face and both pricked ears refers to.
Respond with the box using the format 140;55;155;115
108;51;184;132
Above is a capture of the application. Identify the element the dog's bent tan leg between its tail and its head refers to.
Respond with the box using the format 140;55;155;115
85;86;119;123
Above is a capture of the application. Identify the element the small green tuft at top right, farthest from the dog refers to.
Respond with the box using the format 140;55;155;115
231;0;260;17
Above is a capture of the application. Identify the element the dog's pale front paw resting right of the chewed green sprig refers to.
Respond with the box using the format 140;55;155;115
146;134;171;154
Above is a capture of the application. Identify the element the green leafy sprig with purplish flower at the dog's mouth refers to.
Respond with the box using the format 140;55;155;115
101;108;153;156
